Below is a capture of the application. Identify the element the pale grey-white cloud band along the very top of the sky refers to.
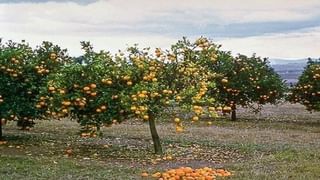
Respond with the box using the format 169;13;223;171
0;0;320;31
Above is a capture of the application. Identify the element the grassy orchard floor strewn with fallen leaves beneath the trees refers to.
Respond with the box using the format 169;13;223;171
0;104;320;180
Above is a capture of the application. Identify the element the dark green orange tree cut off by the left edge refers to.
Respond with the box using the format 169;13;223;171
0;41;33;138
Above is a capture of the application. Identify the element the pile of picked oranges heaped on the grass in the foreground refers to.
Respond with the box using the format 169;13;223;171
141;167;231;180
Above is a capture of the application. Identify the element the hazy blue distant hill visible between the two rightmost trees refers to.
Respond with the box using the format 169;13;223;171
269;59;307;84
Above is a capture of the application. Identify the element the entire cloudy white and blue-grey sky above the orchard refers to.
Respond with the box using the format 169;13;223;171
0;0;320;59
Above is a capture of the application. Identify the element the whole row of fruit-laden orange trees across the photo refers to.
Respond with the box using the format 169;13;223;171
0;38;320;153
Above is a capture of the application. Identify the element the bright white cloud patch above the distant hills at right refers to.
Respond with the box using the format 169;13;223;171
218;27;320;59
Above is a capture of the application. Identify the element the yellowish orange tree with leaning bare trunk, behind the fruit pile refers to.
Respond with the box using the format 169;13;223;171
128;38;219;154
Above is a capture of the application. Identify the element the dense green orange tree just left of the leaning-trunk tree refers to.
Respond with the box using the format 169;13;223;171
38;42;127;136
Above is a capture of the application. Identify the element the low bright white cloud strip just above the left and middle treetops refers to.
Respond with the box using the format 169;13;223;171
0;33;178;56
